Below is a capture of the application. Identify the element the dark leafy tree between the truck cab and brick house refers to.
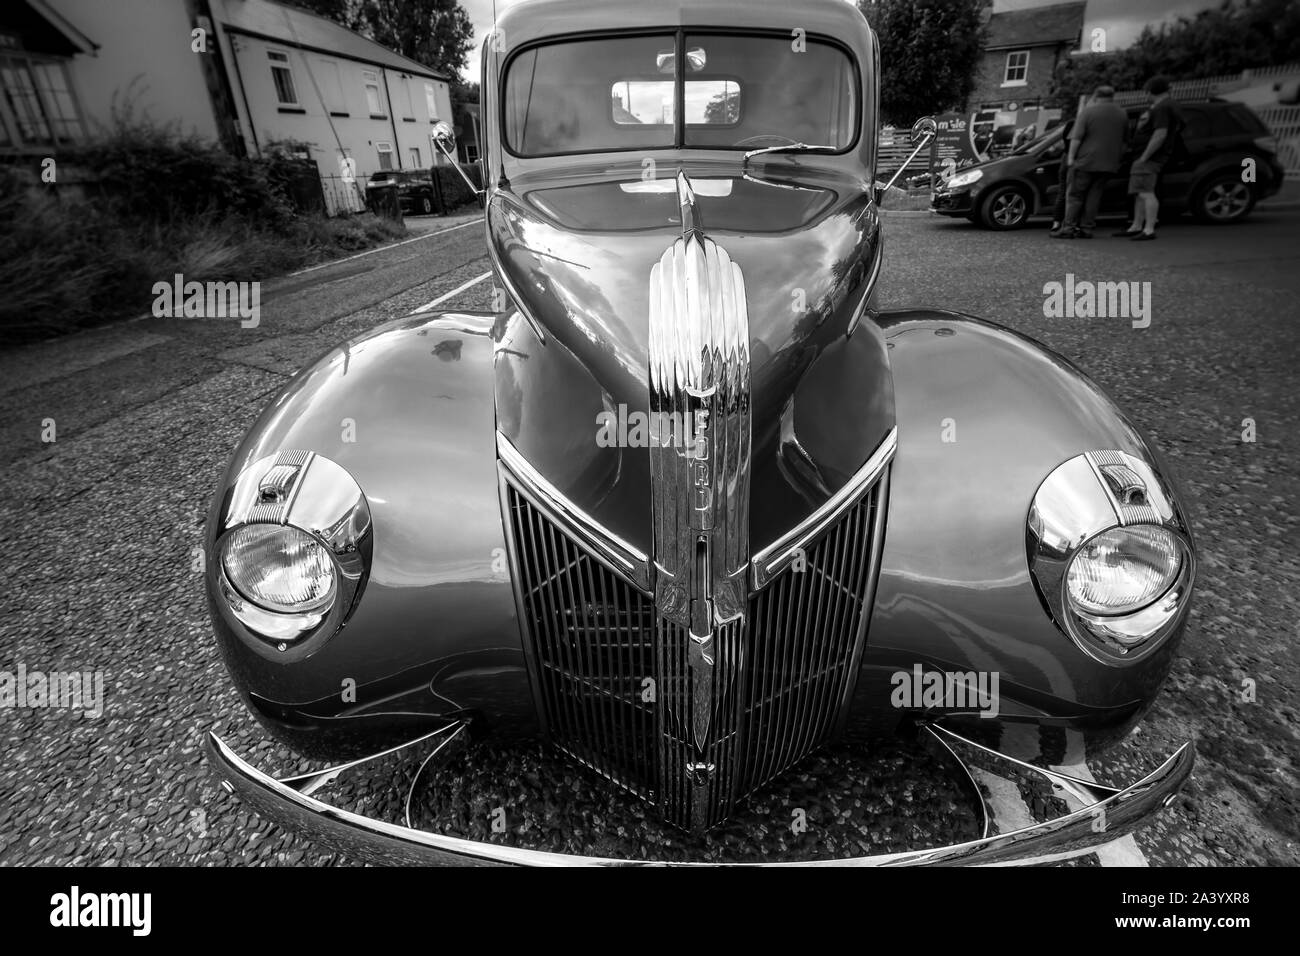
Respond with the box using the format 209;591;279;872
858;0;985;126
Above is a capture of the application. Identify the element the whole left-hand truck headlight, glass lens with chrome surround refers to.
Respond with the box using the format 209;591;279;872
209;450;373;661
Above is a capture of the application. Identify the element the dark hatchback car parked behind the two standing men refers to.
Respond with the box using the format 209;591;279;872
931;101;1284;229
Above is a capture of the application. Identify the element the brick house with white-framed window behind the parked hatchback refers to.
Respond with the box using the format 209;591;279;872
970;3;1088;109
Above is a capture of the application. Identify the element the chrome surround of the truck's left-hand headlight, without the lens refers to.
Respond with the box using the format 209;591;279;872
209;450;373;661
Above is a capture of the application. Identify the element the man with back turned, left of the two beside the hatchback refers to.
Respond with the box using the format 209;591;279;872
1049;86;1128;239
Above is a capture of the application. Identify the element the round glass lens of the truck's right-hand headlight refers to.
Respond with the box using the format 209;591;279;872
1066;525;1182;614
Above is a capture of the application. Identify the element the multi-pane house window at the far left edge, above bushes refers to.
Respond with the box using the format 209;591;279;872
0;56;86;146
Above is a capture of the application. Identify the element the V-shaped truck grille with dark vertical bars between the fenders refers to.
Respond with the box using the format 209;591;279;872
503;463;887;830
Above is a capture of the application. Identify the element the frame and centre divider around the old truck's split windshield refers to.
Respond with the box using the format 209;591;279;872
495;27;866;160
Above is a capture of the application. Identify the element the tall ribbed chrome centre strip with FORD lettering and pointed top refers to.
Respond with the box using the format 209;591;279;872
649;172;751;825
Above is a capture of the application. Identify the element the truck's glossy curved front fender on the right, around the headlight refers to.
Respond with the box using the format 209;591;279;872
857;311;1182;753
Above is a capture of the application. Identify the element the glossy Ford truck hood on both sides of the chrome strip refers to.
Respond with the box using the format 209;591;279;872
488;157;893;561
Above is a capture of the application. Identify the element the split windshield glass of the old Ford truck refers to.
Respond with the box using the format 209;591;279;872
503;34;858;156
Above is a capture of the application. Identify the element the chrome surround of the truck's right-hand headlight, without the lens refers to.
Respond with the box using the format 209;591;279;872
1026;450;1196;666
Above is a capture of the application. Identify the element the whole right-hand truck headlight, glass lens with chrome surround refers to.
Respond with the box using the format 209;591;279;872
1027;451;1196;665
